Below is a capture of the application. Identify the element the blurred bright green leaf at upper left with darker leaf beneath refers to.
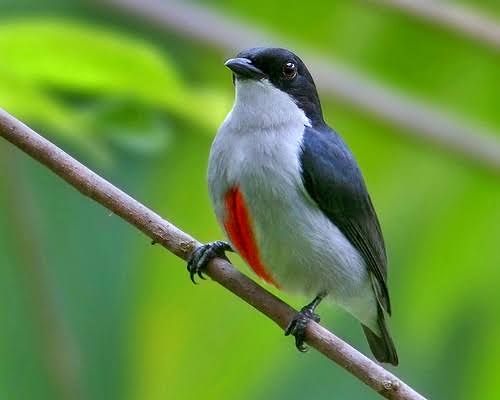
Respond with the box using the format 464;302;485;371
0;18;229;160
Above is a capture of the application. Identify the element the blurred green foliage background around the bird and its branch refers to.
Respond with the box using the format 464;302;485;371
0;0;500;400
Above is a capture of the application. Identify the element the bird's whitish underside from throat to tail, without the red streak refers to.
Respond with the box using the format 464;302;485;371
209;81;378;331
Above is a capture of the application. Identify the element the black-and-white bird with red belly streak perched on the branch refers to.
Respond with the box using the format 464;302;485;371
187;47;398;365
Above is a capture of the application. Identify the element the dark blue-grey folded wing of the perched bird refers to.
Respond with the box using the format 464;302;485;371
300;125;391;314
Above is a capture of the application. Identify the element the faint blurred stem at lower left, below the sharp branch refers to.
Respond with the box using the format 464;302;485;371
0;148;85;400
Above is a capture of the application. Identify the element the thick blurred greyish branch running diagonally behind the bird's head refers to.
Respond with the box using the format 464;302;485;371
104;0;500;174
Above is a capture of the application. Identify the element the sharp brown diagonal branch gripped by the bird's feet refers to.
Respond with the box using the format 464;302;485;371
0;109;425;400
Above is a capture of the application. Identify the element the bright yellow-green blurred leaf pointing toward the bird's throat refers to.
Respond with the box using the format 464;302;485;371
0;19;228;129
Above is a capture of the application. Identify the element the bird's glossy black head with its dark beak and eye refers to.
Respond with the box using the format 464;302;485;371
225;47;323;124
